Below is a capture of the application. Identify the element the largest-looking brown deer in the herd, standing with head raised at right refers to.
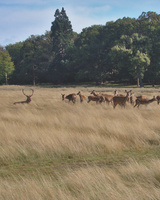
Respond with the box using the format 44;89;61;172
113;90;132;108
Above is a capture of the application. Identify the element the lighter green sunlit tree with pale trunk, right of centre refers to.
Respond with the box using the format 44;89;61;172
111;33;150;87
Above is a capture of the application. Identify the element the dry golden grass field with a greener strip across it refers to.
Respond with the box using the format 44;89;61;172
0;86;160;200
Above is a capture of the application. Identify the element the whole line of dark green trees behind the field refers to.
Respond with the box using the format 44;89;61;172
0;8;160;86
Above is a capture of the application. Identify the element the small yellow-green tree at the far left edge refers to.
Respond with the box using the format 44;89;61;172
0;49;14;82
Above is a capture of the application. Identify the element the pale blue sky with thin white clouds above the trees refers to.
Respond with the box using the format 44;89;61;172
0;0;160;47
